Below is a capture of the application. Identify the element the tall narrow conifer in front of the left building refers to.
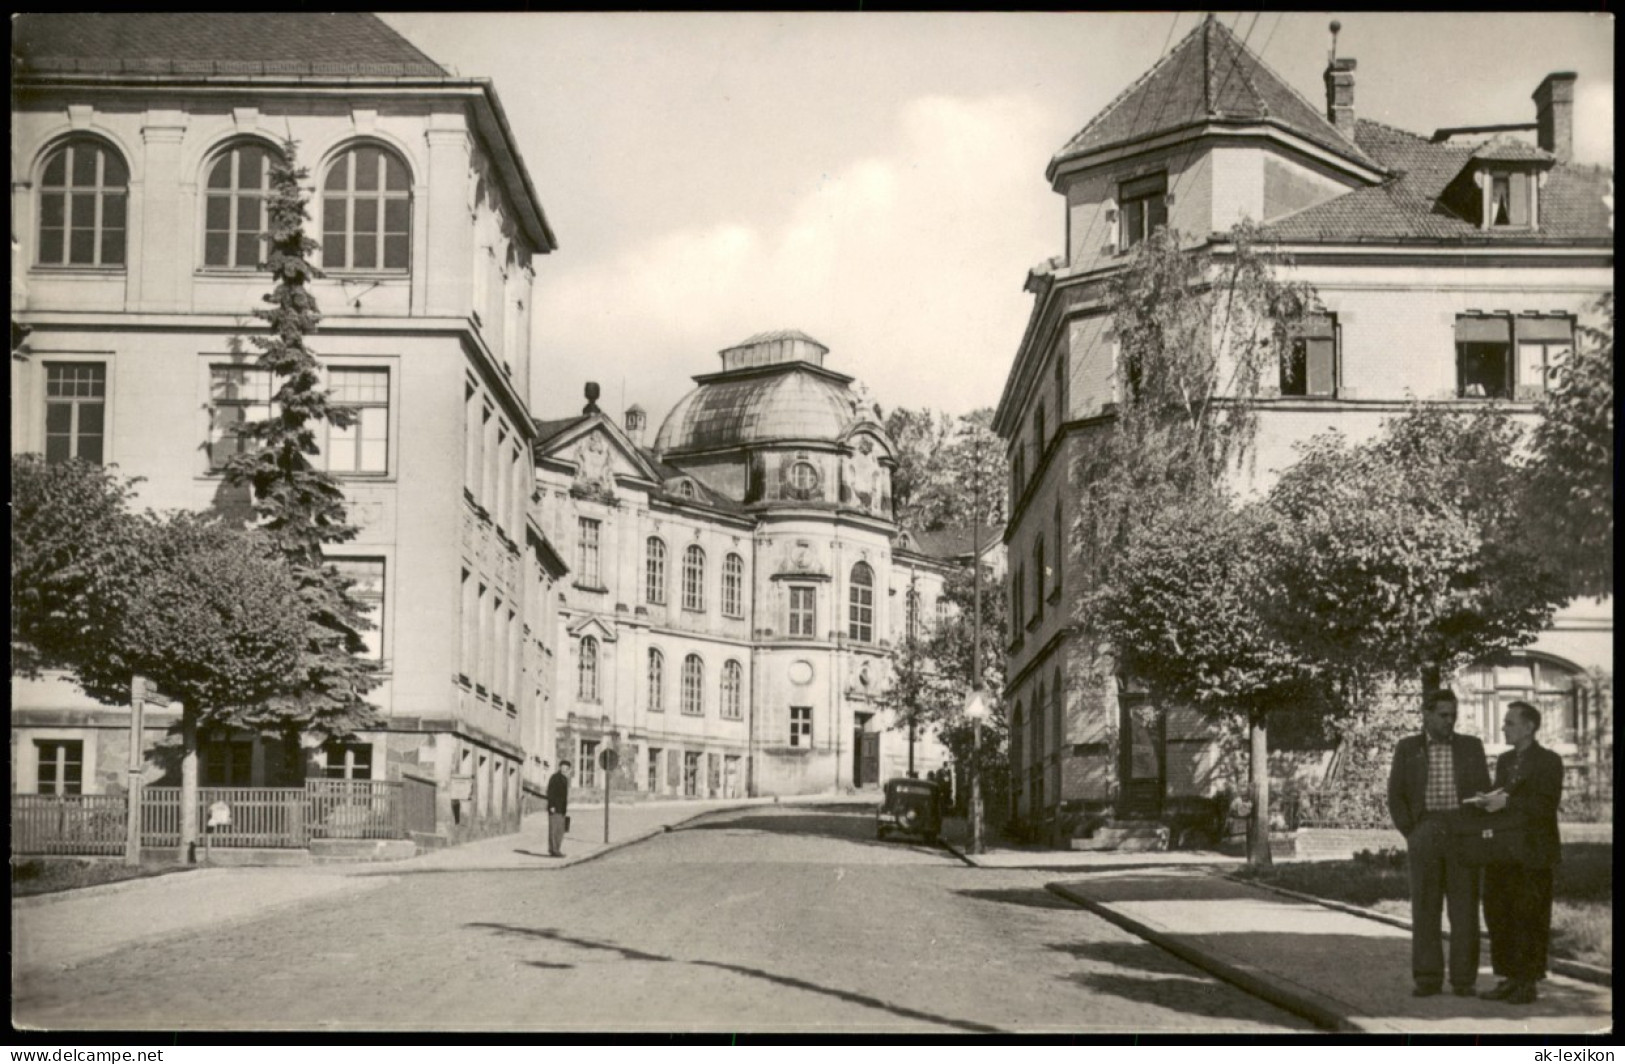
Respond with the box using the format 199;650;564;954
226;141;379;757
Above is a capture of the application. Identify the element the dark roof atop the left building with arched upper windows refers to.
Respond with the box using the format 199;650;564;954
11;13;447;78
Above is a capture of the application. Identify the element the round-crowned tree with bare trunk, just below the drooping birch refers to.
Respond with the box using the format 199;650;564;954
1095;494;1346;866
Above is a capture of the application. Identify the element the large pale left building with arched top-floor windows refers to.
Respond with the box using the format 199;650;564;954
11;15;564;841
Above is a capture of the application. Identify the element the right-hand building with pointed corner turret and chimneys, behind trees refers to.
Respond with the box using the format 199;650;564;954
995;16;1614;825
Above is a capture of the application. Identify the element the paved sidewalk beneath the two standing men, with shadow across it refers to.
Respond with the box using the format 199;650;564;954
1050;854;1614;1035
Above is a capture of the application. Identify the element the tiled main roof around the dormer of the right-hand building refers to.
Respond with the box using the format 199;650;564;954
1261;119;1614;244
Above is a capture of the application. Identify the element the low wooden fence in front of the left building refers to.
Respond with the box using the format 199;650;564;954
11;780;412;856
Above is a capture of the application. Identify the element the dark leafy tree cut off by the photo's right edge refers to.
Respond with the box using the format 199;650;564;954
1526;292;1614;598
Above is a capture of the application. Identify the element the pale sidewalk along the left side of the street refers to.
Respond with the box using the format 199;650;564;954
11;796;776;984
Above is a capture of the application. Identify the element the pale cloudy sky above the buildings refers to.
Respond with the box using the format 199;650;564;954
384;11;1614;435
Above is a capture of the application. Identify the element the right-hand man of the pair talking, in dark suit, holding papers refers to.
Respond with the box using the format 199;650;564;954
1480;702;1563;1006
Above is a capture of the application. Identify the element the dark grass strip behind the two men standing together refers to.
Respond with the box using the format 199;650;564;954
1237;843;1614;968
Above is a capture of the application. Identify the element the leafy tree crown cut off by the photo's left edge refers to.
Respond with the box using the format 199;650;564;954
11;455;140;679
